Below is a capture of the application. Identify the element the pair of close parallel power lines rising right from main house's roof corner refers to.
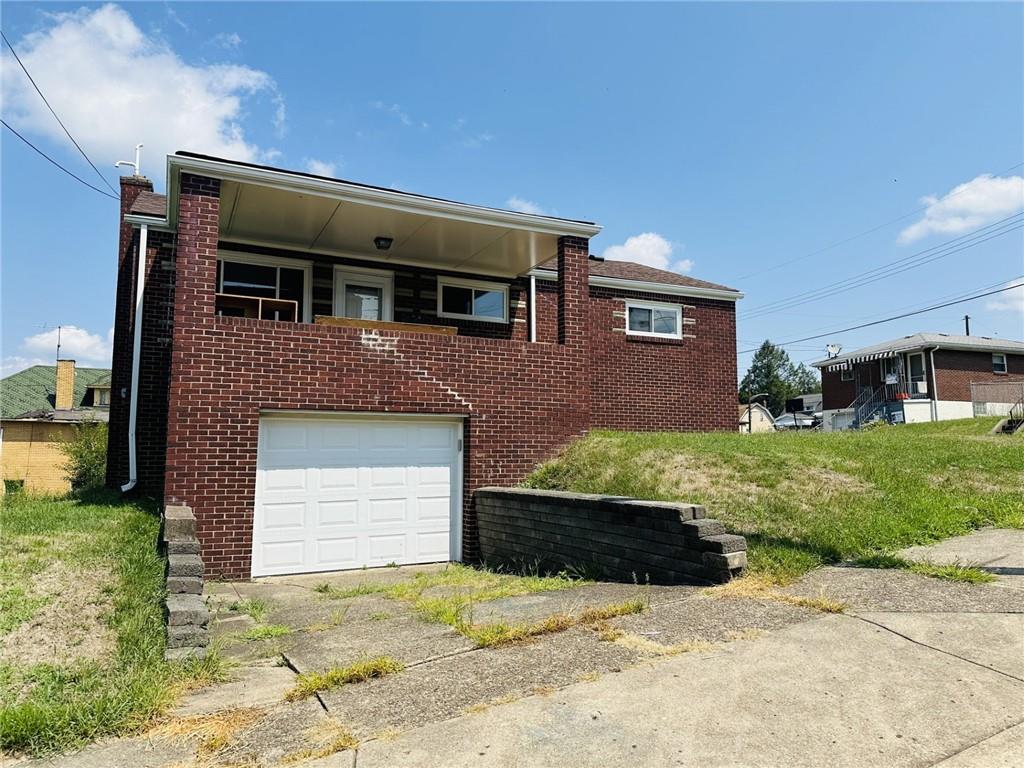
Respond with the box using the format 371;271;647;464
742;213;1024;319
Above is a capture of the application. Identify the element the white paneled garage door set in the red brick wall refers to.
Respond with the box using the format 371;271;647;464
252;416;462;577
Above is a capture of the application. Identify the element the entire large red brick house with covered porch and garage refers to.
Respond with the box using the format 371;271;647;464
108;153;741;578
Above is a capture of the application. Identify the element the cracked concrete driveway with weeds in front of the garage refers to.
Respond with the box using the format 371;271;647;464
29;531;1024;768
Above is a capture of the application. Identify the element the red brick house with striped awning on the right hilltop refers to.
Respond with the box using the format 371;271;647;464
813;333;1024;430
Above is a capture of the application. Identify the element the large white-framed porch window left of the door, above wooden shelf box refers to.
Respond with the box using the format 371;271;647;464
217;251;313;323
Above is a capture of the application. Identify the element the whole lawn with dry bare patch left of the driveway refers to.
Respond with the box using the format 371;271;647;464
0;495;219;755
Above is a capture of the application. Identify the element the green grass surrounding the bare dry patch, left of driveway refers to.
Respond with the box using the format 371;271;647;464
0;495;223;755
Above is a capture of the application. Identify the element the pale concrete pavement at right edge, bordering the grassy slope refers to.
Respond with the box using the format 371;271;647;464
896;528;1024;590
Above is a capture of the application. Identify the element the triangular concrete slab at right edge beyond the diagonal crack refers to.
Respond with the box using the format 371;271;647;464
857;612;1024;679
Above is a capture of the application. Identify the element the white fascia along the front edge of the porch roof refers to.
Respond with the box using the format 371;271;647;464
167;155;601;238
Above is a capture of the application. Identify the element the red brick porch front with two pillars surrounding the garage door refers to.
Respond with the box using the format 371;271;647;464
164;174;590;578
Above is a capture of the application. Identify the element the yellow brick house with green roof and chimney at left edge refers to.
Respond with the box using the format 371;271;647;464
0;360;111;494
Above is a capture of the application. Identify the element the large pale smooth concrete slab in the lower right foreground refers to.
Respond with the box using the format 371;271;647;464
357;615;1024;768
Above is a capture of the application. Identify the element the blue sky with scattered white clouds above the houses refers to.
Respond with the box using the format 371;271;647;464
0;3;1024;372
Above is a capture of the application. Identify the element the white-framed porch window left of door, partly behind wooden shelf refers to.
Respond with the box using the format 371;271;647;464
217;254;311;323
